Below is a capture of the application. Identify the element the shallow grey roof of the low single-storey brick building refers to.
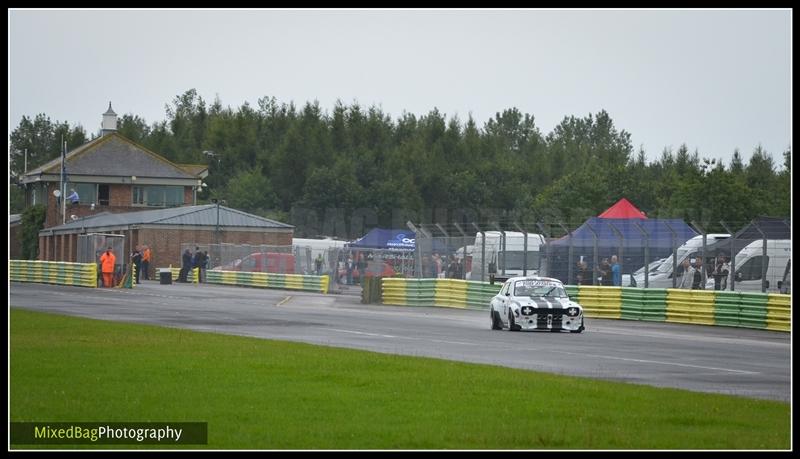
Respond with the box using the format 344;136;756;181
40;204;294;235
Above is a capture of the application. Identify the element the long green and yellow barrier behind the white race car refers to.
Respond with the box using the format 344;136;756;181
382;278;791;331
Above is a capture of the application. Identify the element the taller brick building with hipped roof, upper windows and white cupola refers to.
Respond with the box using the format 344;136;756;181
22;103;208;232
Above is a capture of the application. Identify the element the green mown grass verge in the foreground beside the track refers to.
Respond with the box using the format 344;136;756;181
10;308;790;449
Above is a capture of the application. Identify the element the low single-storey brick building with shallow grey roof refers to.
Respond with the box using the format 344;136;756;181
39;204;294;274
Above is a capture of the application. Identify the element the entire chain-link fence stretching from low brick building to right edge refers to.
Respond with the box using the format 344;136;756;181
175;217;791;293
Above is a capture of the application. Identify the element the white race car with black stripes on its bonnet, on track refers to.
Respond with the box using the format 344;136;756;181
489;276;584;333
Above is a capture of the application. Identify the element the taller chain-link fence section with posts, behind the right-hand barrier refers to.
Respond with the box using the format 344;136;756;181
406;217;791;293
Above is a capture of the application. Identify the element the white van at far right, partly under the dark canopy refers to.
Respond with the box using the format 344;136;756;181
706;239;792;293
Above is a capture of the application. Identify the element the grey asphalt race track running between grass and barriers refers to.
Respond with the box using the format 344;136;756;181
9;281;791;402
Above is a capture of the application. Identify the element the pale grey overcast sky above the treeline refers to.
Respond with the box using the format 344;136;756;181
8;10;792;165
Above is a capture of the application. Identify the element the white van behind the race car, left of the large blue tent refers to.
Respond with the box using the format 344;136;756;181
470;231;545;281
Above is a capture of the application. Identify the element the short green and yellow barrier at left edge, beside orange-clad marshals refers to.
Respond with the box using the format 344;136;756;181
8;260;97;288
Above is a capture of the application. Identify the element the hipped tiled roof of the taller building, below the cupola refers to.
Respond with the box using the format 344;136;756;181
25;132;202;180
